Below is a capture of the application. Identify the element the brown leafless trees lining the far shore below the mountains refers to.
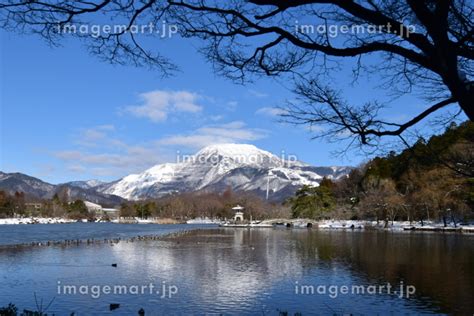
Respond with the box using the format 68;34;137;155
0;189;290;220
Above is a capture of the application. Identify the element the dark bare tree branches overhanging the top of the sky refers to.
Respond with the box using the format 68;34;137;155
0;0;474;145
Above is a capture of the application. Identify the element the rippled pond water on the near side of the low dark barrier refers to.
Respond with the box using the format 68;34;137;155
0;225;474;315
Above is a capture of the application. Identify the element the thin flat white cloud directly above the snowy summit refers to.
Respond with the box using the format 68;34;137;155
158;121;268;149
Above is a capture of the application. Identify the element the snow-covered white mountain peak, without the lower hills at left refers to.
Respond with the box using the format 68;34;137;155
100;144;350;200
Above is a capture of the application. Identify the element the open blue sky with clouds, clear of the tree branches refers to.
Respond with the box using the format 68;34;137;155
0;28;456;183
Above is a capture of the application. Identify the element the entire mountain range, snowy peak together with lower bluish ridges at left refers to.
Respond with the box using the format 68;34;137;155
0;144;352;205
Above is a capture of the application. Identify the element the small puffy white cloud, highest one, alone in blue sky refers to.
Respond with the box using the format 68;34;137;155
124;90;202;123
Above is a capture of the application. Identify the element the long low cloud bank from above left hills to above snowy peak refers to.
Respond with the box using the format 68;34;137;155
53;121;268;178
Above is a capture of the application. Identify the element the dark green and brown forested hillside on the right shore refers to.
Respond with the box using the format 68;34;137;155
288;122;474;223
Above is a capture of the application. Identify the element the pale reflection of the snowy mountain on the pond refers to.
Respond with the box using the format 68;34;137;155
109;229;302;311
